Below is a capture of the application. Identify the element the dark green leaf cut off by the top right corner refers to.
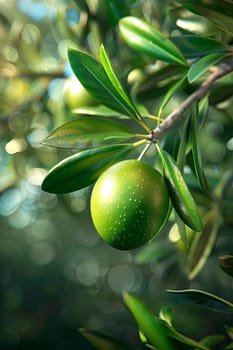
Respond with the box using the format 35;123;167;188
180;0;233;35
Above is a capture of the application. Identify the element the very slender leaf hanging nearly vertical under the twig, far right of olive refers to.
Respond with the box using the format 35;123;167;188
191;103;210;195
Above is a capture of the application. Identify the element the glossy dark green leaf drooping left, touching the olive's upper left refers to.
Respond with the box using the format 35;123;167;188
42;144;134;193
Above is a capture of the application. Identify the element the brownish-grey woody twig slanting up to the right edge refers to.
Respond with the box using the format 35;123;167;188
152;60;233;141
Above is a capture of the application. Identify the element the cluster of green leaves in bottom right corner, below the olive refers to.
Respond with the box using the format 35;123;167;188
80;256;233;350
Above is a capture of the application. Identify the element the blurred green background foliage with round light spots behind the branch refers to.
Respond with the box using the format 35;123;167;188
0;0;233;350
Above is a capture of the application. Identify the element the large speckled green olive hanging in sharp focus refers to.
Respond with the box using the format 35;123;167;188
90;160;169;250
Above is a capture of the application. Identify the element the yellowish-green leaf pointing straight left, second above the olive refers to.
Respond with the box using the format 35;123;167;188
43;117;135;148
